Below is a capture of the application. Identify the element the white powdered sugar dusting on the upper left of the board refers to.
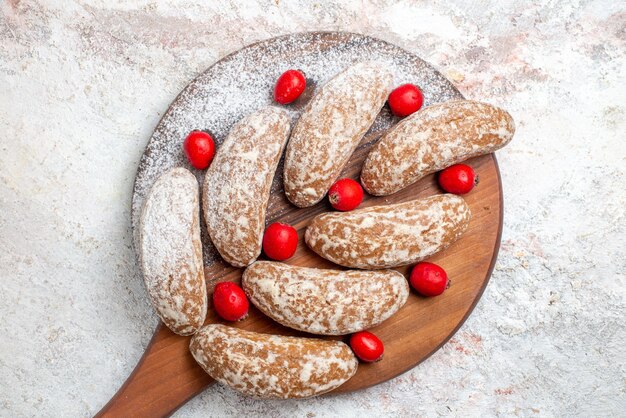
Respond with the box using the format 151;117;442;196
132;32;462;265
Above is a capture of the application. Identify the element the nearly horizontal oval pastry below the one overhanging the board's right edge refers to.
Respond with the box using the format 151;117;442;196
304;194;471;269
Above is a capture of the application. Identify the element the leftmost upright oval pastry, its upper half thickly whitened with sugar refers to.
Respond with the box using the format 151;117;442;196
139;168;207;335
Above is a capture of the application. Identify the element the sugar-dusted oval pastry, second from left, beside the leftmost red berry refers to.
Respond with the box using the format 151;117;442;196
203;107;290;267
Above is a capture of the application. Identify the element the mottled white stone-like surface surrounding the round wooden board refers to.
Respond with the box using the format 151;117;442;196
0;0;626;417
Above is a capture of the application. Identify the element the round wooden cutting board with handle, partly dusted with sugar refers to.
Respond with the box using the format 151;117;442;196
98;32;502;417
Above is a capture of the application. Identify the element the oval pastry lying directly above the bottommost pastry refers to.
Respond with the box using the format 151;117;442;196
241;261;409;335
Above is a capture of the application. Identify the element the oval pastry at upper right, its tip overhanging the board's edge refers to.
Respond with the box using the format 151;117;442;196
361;100;515;196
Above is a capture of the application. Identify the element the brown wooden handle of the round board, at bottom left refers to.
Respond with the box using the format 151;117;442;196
96;323;214;418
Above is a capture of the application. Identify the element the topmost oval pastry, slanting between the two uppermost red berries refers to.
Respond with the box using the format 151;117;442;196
284;62;393;208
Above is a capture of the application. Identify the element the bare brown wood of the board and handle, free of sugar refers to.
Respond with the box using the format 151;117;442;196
97;33;502;417
